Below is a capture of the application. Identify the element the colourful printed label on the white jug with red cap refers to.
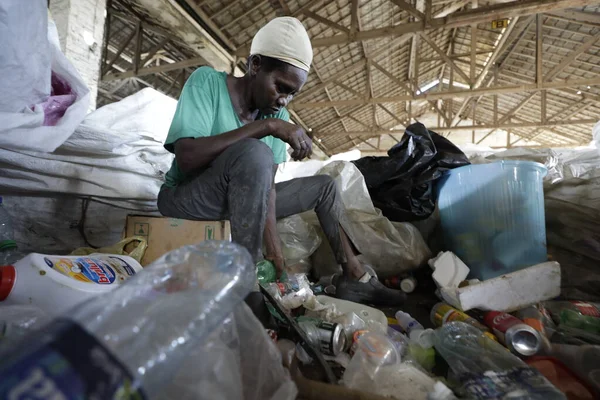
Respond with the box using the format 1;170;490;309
44;256;135;285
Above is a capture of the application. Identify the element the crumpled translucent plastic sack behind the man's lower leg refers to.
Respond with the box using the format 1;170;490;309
280;161;431;278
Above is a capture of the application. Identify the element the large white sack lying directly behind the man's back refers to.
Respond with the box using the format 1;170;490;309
0;88;177;201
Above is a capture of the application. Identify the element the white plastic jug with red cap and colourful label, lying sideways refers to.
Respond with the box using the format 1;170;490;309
0;253;142;315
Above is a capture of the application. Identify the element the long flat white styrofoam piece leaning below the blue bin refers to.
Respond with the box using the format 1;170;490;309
441;261;560;312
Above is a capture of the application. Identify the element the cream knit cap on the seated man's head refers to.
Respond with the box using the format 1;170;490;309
250;17;312;72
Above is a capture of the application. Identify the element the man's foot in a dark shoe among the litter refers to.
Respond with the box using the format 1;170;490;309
332;275;406;307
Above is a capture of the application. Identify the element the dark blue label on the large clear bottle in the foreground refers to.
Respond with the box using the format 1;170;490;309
0;319;146;400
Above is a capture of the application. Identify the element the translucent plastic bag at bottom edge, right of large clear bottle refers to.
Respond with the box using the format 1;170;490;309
160;303;297;400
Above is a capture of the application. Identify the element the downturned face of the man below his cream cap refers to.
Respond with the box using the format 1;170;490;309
252;59;308;115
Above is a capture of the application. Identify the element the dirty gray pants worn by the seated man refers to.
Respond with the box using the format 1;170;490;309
158;139;346;264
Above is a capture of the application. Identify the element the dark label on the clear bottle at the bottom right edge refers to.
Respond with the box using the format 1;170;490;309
459;367;559;400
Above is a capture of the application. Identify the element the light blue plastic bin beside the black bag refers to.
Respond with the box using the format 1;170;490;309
437;161;547;280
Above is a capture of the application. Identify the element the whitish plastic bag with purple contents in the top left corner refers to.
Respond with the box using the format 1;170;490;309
0;0;90;152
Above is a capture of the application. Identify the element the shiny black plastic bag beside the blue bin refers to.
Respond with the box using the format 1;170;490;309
354;123;470;222
